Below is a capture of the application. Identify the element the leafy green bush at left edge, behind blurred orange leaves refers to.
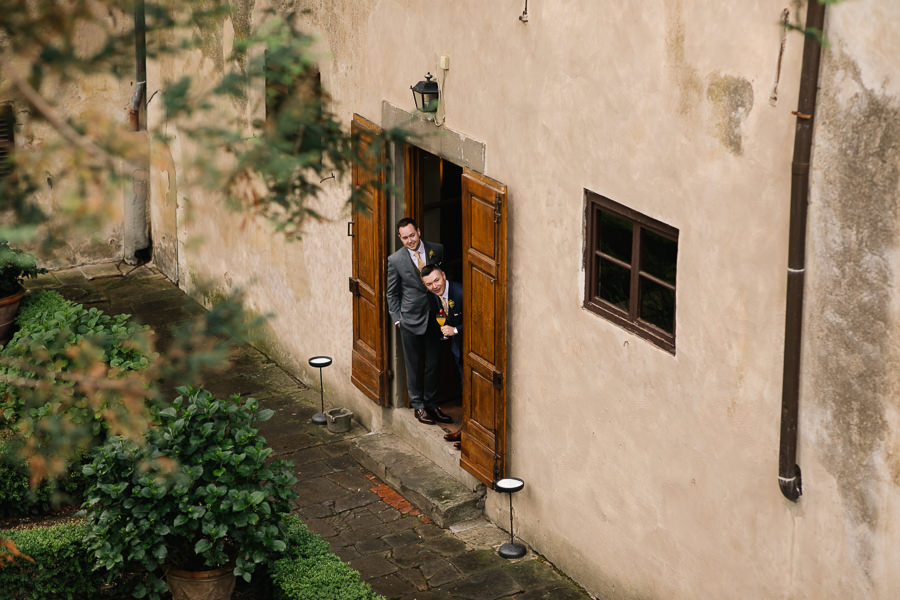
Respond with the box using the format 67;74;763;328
0;291;151;472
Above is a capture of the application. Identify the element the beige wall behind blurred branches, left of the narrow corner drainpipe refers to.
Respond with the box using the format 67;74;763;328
0;12;137;268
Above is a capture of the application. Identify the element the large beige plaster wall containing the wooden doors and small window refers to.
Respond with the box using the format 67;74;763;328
155;0;900;600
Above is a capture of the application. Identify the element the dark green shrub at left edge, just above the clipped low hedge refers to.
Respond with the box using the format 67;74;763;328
0;441;86;517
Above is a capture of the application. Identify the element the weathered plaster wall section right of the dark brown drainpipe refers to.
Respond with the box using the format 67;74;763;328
798;2;900;598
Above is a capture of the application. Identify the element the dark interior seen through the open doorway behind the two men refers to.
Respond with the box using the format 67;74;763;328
407;146;463;408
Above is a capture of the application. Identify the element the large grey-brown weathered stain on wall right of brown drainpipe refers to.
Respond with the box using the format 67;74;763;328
805;47;900;576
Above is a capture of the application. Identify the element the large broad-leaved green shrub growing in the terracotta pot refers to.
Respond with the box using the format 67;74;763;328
84;388;297;600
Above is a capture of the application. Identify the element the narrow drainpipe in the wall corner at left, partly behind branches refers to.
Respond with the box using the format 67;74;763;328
122;0;150;264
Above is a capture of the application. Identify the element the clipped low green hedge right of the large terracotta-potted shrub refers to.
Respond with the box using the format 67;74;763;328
271;516;383;600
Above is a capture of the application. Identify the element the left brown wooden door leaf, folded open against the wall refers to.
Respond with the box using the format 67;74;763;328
350;115;388;406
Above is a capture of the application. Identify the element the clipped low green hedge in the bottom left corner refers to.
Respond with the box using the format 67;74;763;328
0;523;100;600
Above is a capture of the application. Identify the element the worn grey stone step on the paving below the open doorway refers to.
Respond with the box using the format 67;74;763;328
350;431;484;528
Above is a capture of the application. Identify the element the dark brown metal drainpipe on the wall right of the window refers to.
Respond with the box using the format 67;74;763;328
778;0;825;502
